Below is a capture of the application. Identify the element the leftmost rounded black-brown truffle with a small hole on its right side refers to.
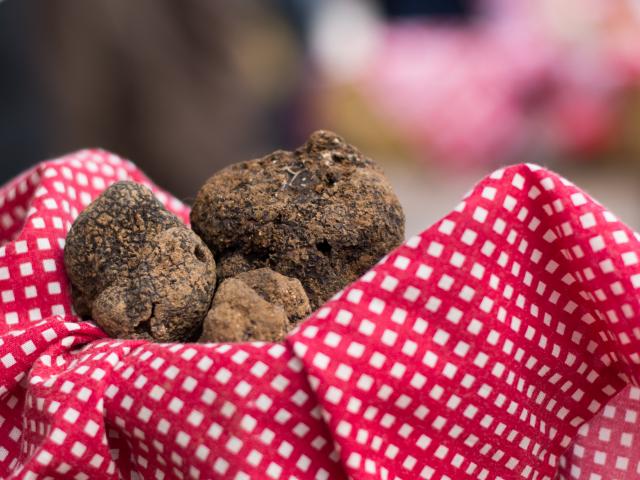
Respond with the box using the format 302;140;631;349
64;182;216;342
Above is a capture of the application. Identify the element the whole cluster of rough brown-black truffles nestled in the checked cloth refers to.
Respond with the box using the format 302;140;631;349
64;131;404;342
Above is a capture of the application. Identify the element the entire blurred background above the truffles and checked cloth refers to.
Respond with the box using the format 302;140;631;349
0;0;640;234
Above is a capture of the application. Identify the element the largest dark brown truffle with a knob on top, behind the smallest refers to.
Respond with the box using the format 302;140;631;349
191;131;404;308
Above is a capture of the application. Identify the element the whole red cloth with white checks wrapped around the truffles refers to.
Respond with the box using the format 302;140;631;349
0;151;640;480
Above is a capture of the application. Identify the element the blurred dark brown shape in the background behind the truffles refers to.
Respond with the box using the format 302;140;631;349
26;0;298;199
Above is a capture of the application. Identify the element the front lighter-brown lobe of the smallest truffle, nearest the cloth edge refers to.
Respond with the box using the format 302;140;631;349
200;278;289;342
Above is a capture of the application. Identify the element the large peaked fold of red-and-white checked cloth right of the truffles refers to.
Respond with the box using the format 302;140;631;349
289;165;640;479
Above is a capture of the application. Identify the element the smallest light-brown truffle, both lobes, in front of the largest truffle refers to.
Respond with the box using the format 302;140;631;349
200;268;311;342
